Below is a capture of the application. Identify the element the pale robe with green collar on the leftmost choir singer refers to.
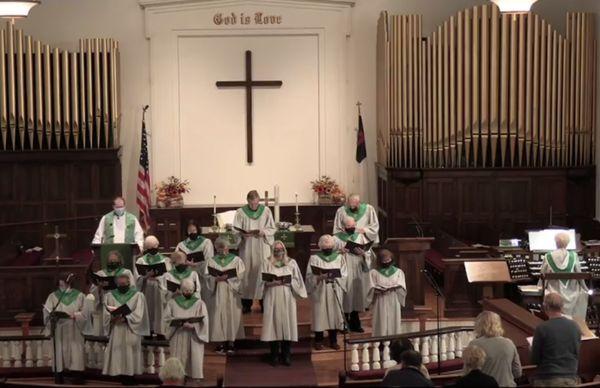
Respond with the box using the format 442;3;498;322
44;289;93;372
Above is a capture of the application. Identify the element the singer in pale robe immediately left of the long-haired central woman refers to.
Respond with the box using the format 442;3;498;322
205;238;245;354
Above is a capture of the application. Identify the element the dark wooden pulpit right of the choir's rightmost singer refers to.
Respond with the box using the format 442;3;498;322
384;237;435;318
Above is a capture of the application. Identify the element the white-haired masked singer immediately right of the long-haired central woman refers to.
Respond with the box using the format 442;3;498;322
306;234;347;350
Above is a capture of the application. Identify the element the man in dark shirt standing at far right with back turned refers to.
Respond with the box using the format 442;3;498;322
531;292;581;387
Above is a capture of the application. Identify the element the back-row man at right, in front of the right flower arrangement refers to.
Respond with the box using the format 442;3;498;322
333;194;379;244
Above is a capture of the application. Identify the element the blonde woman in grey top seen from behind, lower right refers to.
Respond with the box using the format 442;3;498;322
469;311;521;387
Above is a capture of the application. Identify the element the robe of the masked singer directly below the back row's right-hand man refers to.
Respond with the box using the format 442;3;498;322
334;232;372;313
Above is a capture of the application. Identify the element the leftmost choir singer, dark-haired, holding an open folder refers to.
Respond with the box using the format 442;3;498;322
44;274;91;384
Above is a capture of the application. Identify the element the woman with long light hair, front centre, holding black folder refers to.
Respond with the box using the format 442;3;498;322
258;241;307;366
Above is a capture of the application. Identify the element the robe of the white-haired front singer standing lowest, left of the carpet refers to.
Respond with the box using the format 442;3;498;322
164;295;209;379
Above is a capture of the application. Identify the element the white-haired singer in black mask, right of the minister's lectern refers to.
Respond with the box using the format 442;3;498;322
135;236;170;338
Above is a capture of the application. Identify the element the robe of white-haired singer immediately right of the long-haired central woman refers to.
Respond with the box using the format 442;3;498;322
306;252;348;331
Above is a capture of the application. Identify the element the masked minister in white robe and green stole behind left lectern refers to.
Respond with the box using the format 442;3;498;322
92;197;144;252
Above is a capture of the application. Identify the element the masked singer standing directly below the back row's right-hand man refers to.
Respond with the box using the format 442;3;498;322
334;217;372;333
